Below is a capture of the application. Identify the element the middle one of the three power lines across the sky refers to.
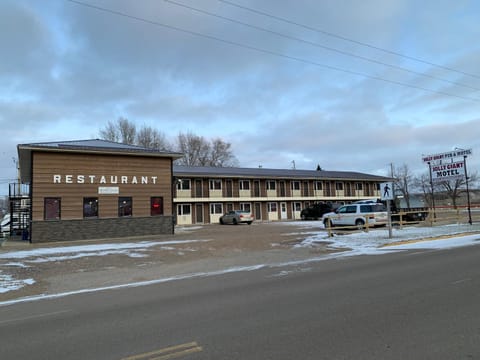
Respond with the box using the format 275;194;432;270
164;0;480;91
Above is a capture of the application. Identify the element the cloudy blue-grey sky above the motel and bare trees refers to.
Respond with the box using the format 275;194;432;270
0;0;480;196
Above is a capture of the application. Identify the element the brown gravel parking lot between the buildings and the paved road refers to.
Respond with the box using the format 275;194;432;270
0;223;331;301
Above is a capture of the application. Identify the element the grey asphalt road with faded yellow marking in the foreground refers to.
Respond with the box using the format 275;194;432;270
0;246;480;360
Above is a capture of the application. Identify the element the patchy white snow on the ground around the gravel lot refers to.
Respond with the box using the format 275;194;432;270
0;222;480;300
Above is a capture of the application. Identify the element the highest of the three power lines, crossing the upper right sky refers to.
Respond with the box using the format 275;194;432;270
218;0;480;79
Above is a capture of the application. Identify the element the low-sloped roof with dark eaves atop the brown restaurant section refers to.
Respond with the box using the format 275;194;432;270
17;139;183;182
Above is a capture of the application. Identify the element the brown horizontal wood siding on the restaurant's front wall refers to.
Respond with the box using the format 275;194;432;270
32;152;172;221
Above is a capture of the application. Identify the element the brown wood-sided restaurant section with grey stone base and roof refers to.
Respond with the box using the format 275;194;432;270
13;140;182;242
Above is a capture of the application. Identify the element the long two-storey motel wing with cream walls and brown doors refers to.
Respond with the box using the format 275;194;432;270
173;165;390;225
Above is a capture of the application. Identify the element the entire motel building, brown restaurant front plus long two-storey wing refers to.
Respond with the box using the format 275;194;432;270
9;139;388;242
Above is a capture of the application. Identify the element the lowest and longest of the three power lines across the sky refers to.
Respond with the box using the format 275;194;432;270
66;0;480;102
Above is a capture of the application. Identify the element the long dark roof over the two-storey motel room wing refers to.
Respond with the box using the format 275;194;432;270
173;165;390;182
